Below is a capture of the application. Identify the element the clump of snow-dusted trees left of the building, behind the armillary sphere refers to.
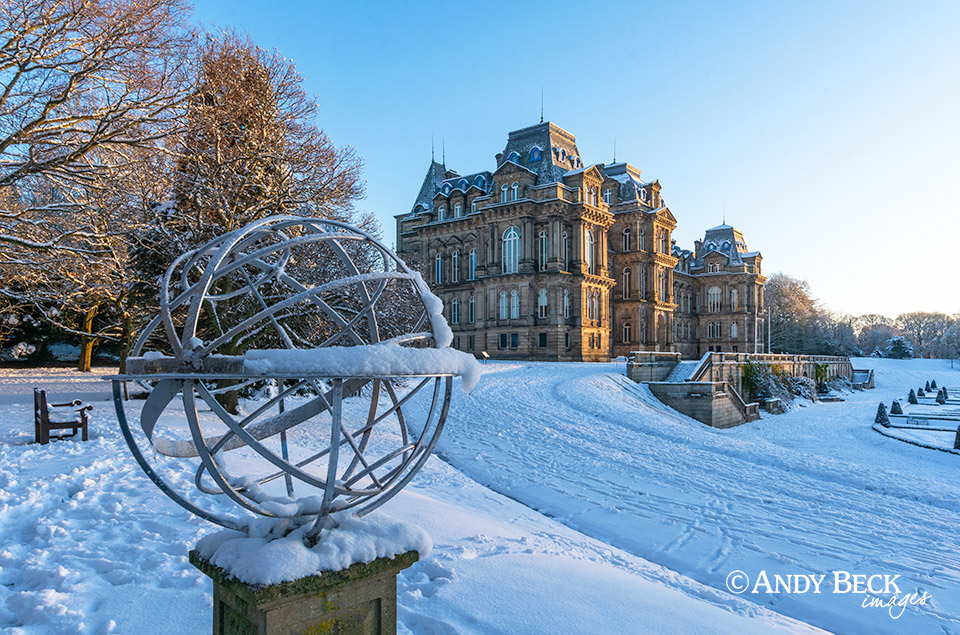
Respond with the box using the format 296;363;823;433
0;0;379;370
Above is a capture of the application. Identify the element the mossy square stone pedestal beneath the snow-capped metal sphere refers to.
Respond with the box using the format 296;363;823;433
190;551;419;635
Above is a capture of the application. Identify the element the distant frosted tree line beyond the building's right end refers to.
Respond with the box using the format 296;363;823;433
764;273;960;359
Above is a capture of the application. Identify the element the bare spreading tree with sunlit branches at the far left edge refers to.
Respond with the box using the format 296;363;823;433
0;0;193;368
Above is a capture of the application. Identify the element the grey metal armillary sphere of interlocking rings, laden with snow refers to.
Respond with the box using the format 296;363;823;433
113;216;479;541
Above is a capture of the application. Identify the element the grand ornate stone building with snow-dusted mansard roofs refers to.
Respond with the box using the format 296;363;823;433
396;122;764;361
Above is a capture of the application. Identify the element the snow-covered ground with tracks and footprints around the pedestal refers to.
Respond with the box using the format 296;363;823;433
0;360;960;634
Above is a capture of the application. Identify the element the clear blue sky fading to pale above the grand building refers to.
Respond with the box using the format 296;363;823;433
196;0;960;317
